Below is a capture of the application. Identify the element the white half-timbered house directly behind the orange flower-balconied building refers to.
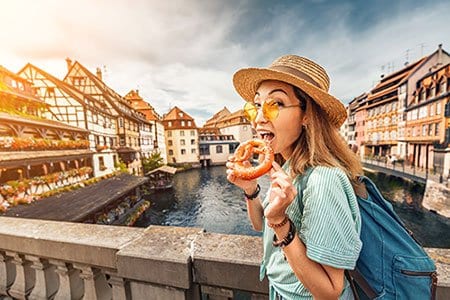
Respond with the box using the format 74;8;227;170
18;64;117;177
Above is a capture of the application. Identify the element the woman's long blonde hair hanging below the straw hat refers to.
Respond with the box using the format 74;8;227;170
276;86;363;187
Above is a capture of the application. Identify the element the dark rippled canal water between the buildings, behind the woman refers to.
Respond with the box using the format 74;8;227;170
135;166;450;248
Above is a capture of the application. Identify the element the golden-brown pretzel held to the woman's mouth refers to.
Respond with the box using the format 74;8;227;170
230;139;274;180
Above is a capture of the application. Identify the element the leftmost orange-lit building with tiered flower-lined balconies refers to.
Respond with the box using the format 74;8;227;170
0;66;92;211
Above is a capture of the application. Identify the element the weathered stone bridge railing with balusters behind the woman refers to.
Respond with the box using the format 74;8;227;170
0;217;450;300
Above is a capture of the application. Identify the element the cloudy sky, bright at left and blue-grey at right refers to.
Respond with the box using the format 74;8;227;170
0;0;450;126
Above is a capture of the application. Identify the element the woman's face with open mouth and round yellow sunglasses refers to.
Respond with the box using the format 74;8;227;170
252;80;306;159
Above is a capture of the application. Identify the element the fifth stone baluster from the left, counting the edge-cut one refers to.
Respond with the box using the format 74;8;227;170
73;264;112;300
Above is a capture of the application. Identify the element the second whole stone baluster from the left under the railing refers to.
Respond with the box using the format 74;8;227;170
25;255;59;300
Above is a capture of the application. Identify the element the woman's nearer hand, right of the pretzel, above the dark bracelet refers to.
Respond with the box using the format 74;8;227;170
264;162;297;224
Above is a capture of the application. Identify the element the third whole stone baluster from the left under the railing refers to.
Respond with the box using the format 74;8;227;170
50;260;84;300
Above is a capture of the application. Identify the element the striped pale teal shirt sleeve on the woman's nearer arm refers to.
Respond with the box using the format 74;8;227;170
299;167;362;269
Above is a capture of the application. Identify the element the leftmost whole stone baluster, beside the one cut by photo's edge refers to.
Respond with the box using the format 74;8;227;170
6;251;36;299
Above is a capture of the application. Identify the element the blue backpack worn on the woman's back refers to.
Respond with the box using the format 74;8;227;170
298;168;437;300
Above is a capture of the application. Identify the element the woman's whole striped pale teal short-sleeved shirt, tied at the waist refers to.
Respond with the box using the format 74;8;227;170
260;163;362;300
